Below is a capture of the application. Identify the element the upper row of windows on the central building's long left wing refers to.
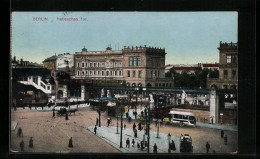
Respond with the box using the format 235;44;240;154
77;62;122;68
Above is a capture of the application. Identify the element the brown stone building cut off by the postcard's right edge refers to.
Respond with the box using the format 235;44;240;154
207;41;238;89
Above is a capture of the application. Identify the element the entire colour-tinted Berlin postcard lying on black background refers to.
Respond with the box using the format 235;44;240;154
10;11;239;155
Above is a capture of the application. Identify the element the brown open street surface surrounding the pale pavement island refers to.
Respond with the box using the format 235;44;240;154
10;108;237;153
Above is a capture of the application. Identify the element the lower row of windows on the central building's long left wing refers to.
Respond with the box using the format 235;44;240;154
77;71;123;76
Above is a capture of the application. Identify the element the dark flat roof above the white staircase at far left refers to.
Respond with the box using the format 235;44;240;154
12;68;51;76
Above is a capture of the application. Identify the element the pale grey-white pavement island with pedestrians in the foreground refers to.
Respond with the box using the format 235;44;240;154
88;126;180;153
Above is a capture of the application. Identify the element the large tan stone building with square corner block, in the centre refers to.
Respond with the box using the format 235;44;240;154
74;46;173;87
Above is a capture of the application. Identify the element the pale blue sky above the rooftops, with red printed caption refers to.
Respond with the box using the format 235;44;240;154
11;12;238;64
